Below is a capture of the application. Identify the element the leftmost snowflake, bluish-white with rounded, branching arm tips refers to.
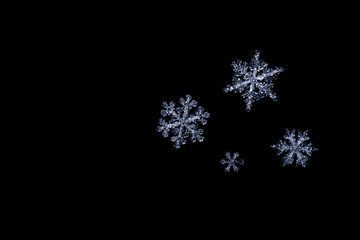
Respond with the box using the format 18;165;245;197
157;95;210;148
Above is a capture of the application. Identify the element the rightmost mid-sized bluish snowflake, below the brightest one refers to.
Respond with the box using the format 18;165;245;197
271;129;318;167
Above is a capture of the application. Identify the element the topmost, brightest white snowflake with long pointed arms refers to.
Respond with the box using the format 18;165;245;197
224;51;284;112
